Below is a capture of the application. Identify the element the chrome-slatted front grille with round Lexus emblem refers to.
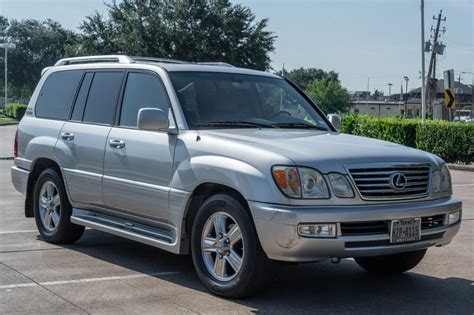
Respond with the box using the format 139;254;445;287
348;164;431;200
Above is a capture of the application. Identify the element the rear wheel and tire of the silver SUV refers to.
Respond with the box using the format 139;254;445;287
33;168;84;244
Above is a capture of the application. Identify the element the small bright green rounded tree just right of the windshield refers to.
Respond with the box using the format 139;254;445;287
305;79;352;113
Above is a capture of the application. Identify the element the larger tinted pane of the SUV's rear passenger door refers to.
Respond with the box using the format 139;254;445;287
83;71;123;125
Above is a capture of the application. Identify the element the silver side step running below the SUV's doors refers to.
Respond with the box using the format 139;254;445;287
71;208;176;252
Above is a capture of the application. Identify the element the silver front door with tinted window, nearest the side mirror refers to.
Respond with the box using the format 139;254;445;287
102;72;177;220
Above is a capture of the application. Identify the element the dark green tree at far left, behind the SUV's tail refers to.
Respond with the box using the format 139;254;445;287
0;17;77;98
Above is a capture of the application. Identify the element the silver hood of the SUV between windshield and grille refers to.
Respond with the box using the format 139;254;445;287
196;129;442;173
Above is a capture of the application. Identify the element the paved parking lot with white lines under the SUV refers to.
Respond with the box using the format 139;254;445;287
0;126;474;314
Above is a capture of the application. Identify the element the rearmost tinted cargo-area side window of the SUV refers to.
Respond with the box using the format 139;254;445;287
35;70;84;119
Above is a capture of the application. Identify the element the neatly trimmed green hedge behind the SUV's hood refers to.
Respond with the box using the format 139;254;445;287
342;115;474;163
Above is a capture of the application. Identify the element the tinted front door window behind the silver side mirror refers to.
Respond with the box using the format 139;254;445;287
120;73;170;127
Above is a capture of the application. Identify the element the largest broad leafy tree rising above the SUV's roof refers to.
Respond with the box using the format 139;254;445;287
80;0;275;70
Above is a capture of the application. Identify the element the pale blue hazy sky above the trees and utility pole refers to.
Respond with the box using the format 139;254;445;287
0;0;474;95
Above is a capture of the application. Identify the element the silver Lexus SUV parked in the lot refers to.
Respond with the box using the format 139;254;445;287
11;56;462;297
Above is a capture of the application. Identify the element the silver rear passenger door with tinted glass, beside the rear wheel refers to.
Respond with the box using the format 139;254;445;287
56;70;124;206
